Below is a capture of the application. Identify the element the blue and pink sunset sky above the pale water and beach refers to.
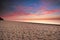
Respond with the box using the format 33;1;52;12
0;0;60;23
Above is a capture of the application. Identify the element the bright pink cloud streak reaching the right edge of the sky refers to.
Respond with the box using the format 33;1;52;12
37;6;60;15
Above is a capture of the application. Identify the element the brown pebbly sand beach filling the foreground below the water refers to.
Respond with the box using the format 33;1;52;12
0;21;60;40
